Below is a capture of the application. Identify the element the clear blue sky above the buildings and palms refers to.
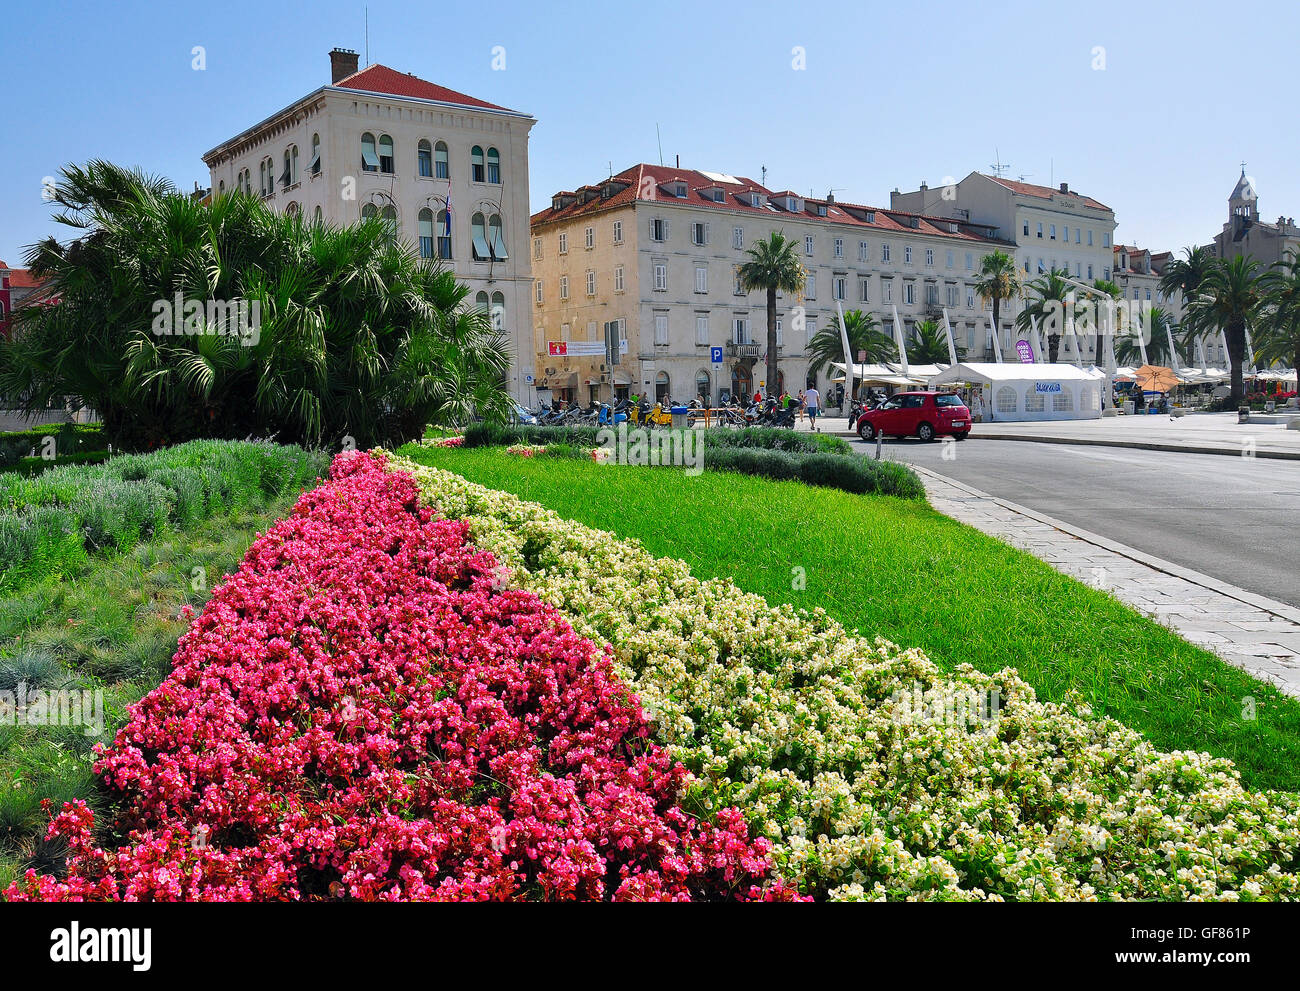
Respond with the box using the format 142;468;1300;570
0;0;1300;265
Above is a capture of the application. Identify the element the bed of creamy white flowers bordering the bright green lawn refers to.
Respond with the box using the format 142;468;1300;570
391;458;1300;900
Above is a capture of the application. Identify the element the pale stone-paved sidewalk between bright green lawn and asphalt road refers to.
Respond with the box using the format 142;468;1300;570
914;466;1300;697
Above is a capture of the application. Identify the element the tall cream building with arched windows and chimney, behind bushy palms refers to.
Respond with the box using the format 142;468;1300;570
203;48;536;399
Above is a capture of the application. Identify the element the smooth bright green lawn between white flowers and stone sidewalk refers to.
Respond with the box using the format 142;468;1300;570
402;446;1300;791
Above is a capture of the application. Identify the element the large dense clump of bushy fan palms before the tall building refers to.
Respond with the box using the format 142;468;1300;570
0;161;510;449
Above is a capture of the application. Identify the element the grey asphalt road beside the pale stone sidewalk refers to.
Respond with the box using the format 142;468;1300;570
854;440;1300;606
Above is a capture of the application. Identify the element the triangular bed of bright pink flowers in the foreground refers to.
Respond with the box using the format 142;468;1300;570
5;454;796;900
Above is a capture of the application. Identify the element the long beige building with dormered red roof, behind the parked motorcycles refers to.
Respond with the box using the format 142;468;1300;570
532;165;1011;403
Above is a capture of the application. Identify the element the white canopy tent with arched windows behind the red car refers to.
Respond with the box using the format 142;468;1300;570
930;362;1109;421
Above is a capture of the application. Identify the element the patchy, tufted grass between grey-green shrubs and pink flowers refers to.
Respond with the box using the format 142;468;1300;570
0;492;298;890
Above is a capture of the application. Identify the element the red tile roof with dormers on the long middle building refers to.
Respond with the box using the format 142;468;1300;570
530;164;1010;244
